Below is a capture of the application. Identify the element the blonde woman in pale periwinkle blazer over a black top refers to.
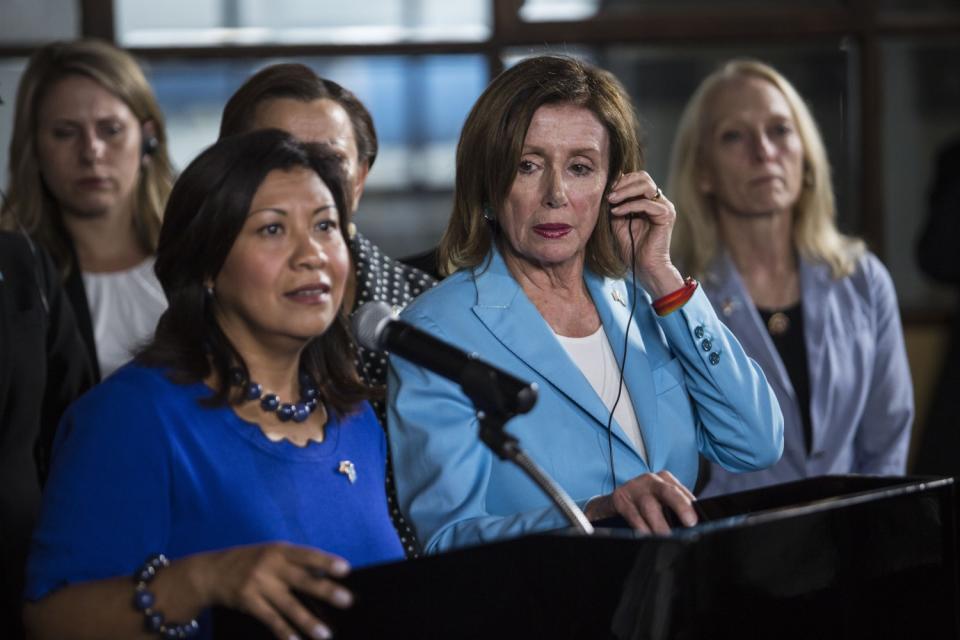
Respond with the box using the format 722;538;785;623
669;60;913;495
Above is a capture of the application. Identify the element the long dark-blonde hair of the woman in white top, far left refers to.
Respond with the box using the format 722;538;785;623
0;39;173;275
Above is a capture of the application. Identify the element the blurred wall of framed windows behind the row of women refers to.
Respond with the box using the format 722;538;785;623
0;0;960;470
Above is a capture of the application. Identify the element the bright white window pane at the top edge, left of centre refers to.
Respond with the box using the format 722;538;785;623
116;0;491;46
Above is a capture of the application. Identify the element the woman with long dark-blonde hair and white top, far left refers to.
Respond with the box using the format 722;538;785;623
2;40;173;377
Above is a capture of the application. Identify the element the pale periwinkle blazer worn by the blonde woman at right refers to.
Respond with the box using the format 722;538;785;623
702;253;913;496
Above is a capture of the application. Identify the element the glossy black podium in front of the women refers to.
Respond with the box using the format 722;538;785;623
214;476;960;640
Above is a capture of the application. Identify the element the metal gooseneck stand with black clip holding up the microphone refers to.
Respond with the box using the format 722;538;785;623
460;363;593;535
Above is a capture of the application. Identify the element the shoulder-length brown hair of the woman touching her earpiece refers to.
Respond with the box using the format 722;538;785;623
439;56;643;277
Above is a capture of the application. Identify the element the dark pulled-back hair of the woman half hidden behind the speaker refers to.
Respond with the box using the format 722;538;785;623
220;63;377;167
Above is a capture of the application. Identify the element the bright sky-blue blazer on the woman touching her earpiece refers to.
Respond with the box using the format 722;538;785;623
387;251;783;552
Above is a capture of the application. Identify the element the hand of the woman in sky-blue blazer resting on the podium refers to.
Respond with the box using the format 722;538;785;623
584;470;698;534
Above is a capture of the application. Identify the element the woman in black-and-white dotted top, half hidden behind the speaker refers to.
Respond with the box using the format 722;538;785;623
220;63;436;558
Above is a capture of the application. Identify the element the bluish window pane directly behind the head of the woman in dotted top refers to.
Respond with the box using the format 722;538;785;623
146;55;487;256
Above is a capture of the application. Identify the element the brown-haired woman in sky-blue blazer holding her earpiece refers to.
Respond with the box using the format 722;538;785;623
388;56;782;552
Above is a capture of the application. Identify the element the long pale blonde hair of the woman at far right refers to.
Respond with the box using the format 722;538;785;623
667;59;864;278
